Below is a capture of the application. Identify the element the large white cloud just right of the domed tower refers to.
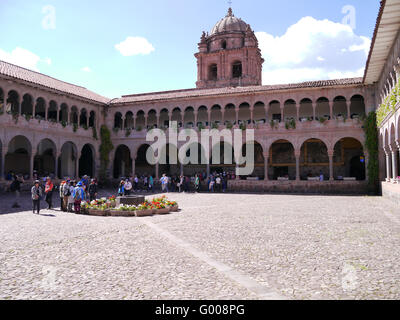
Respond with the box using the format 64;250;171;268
256;17;371;84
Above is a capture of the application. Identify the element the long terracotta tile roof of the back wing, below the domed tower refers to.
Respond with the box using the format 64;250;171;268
111;78;362;105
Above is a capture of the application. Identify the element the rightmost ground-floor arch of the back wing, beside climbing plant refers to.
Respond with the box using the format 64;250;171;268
333;137;366;180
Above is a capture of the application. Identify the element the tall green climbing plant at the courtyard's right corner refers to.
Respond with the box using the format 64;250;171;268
364;111;379;192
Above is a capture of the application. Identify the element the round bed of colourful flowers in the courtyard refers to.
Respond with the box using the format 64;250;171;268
81;196;178;217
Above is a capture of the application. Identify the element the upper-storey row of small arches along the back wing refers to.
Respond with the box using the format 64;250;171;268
113;94;366;130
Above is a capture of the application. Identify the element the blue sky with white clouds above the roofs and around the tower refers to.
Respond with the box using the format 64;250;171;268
0;0;379;98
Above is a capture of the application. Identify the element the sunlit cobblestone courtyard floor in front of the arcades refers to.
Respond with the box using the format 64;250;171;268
0;194;400;299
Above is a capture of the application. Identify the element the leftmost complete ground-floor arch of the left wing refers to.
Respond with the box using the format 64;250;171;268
4;135;32;176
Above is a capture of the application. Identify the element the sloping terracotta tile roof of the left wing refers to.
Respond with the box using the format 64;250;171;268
0;60;110;104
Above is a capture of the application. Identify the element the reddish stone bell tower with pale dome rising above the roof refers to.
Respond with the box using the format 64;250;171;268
195;8;264;88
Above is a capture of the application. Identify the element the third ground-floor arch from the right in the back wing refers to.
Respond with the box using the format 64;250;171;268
268;139;296;180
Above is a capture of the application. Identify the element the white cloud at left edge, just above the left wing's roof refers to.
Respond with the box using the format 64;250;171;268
0;47;45;71
